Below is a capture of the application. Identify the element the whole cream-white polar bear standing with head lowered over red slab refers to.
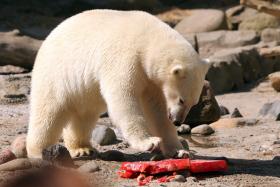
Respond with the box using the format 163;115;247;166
27;10;208;158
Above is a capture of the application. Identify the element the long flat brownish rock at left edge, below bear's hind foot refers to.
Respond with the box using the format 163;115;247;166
0;158;50;171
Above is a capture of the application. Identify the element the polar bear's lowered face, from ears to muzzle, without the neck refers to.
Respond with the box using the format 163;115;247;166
162;58;209;125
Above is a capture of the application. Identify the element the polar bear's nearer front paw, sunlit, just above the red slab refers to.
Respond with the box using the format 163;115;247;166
132;137;162;152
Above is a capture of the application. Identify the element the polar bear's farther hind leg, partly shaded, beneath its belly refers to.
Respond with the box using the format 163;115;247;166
63;115;98;157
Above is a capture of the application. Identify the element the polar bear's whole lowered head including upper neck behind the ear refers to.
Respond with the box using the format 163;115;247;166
149;42;209;125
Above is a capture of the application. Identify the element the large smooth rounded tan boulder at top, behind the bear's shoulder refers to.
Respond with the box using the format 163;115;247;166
175;9;226;34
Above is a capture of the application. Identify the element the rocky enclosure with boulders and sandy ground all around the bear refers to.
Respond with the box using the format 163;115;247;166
0;0;280;186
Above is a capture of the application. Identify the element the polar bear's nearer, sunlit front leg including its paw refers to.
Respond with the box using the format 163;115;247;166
101;81;161;151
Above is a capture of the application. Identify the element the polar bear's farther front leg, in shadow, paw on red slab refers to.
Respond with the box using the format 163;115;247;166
142;91;190;158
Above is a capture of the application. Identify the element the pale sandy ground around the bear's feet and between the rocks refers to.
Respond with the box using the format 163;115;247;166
0;78;280;187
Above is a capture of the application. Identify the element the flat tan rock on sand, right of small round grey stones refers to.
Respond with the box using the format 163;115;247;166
209;118;259;129
